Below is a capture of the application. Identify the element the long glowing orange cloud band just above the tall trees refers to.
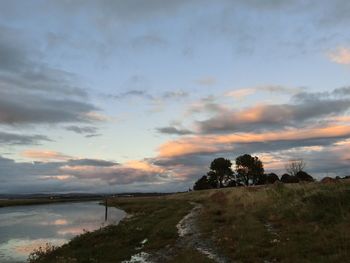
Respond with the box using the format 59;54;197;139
158;126;350;158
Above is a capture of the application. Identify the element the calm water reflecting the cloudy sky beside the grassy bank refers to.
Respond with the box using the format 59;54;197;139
0;202;125;263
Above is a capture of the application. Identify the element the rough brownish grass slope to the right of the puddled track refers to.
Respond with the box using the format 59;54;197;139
194;183;350;262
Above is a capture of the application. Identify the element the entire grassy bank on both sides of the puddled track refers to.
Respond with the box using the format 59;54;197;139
30;181;350;263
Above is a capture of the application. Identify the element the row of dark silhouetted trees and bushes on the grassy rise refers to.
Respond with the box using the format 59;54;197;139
193;154;314;190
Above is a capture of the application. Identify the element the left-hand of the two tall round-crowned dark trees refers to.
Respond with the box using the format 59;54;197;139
208;157;233;188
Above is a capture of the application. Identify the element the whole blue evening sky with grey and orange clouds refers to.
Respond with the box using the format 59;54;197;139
0;0;350;194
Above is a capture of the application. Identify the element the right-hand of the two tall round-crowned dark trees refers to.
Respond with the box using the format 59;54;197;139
236;154;264;185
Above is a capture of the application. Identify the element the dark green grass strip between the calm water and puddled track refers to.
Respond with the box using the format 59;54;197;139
30;197;206;263
